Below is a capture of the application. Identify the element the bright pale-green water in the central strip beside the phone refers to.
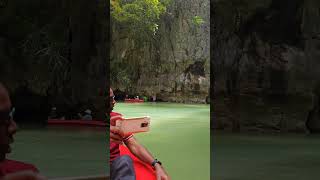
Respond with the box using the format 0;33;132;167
114;103;210;180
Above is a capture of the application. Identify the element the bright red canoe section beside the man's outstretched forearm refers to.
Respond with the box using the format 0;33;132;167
120;145;157;180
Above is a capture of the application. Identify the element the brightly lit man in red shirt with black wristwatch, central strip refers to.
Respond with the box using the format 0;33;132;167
108;88;169;180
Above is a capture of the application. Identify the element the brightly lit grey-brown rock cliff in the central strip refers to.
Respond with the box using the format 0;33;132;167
111;0;210;103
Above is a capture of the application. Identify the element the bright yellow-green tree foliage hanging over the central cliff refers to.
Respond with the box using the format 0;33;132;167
110;0;169;90
